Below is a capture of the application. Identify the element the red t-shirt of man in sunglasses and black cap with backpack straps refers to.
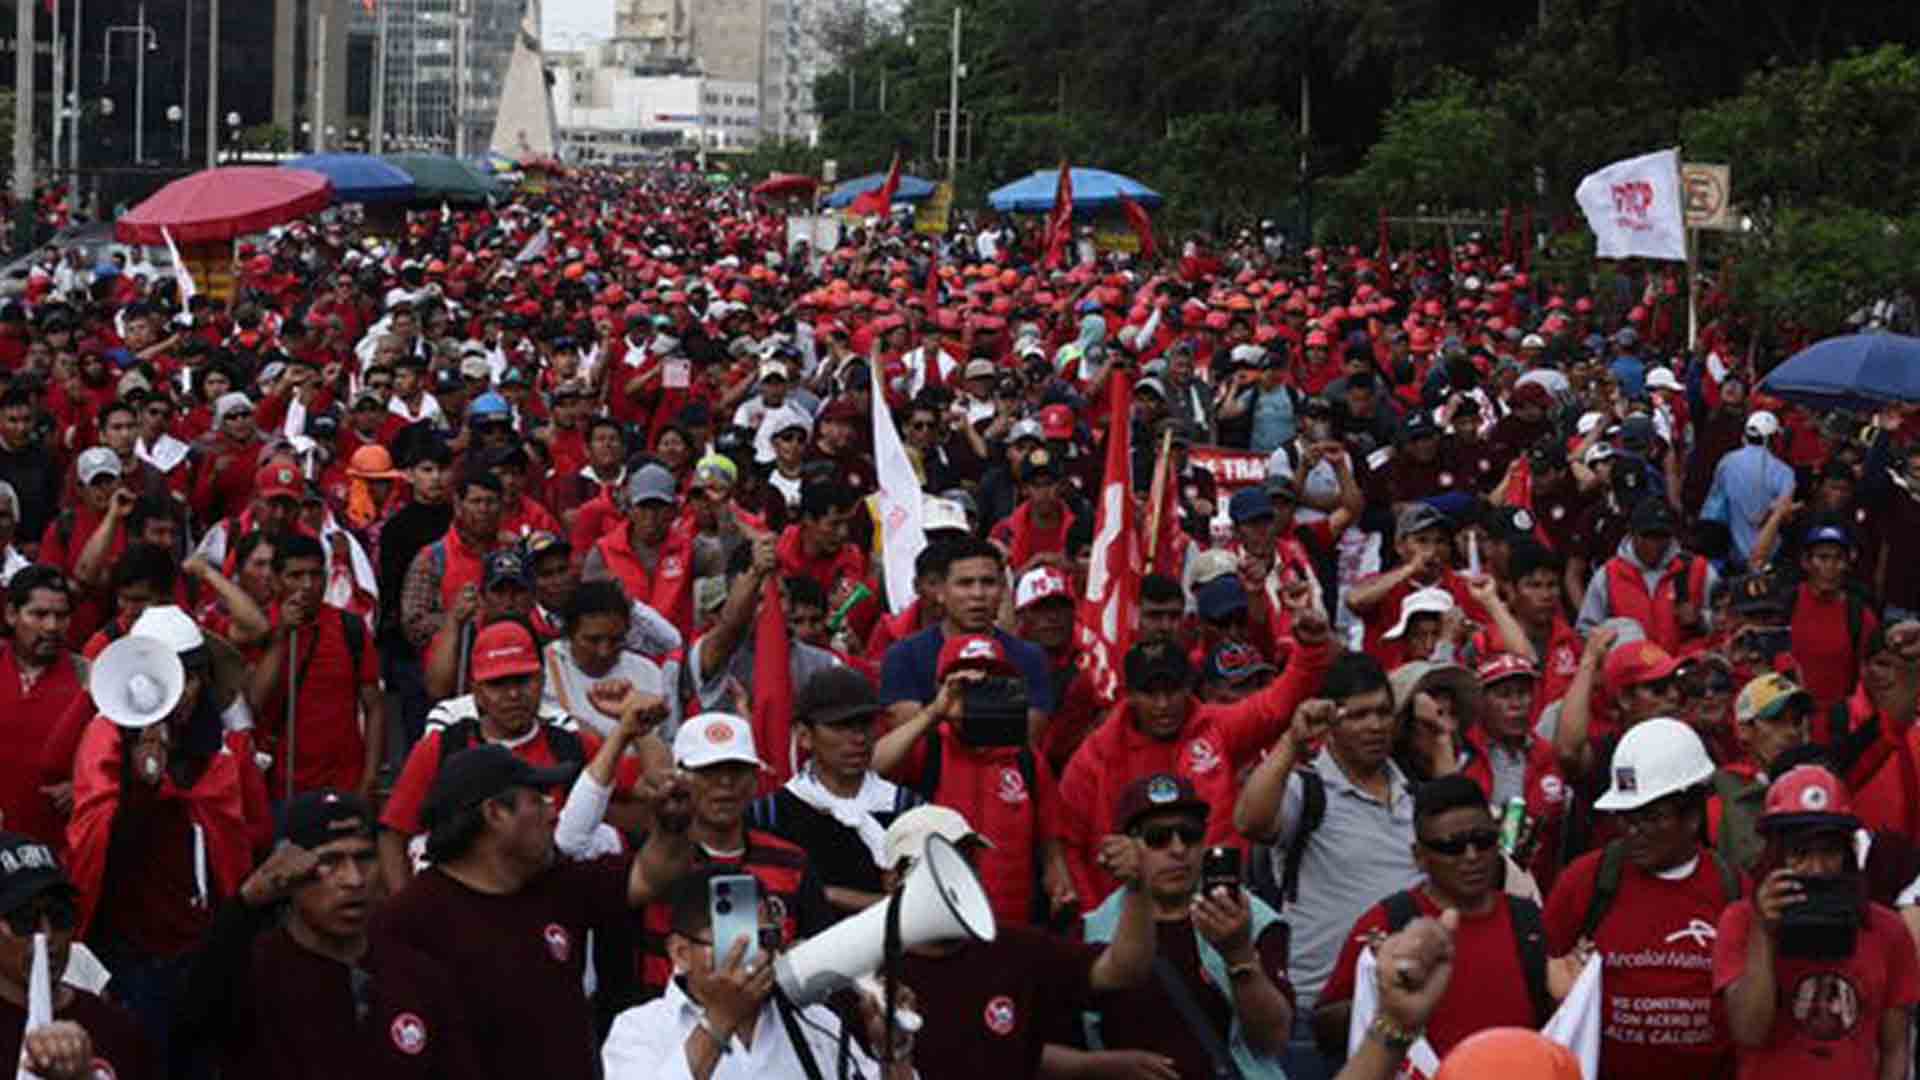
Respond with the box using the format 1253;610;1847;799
1319;888;1540;1057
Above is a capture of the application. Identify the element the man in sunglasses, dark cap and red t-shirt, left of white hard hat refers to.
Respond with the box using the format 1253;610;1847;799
1313;774;1586;1057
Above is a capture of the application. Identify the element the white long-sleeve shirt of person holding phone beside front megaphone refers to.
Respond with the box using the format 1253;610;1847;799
601;980;906;1080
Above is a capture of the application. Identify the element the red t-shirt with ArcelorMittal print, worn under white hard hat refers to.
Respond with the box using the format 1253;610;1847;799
1546;851;1732;1080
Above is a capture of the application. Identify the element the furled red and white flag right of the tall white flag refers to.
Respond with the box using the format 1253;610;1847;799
1073;373;1140;701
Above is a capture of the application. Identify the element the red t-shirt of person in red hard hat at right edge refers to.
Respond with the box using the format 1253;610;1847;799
1713;899;1920;1080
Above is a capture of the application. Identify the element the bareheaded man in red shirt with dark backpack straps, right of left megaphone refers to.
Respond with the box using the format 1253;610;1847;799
248;532;386;798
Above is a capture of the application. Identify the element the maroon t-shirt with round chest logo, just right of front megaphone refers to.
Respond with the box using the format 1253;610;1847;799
900;924;1100;1080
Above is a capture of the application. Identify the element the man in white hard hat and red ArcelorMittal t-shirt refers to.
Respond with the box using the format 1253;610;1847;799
1546;719;1745;1080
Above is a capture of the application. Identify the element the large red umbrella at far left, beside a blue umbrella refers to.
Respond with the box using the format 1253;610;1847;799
113;165;334;244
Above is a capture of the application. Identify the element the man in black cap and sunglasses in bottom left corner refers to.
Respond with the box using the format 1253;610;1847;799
0;832;149;1080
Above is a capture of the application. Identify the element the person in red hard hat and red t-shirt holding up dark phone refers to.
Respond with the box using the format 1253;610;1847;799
1713;765;1920;1080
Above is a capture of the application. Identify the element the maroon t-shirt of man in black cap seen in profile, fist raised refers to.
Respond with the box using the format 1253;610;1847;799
371;857;632;1080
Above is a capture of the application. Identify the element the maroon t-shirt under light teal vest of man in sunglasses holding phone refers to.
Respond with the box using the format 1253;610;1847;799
1098;919;1294;1076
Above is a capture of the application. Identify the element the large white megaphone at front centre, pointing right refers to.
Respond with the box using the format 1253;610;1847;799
774;836;995;1006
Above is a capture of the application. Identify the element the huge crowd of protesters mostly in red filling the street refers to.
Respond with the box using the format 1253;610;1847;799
0;161;1920;1080
